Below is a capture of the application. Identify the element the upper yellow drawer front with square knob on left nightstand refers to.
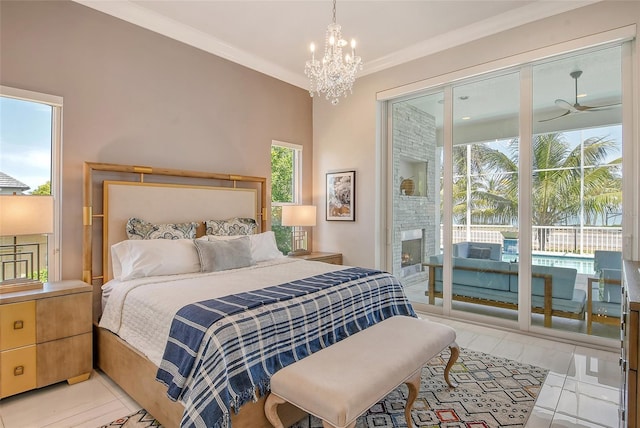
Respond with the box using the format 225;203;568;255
0;301;36;351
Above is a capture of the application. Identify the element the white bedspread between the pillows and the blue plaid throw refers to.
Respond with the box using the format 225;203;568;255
100;258;347;366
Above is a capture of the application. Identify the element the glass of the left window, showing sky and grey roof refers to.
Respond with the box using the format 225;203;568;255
0;97;53;281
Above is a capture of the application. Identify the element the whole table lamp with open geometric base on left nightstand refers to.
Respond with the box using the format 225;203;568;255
0;195;53;294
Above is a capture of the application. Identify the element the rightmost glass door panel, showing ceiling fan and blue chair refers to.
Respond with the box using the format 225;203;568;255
531;46;622;338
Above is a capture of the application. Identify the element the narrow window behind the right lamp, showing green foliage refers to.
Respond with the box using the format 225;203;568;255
271;141;302;254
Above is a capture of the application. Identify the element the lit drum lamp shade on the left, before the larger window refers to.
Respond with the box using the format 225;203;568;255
0;195;53;236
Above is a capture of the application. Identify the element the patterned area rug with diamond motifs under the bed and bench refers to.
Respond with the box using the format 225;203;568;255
101;349;548;428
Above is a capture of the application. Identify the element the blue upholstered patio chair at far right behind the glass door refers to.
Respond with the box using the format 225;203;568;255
587;251;622;334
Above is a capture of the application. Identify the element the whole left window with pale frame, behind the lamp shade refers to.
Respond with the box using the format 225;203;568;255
0;86;62;281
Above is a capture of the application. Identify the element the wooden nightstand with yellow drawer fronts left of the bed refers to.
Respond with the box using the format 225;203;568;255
0;281;93;398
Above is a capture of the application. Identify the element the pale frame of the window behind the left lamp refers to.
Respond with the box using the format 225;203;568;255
0;85;63;282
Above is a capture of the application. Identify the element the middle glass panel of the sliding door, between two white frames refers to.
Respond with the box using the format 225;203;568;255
452;73;520;321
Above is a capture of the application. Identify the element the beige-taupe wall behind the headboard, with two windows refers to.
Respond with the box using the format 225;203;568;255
0;1;312;279
